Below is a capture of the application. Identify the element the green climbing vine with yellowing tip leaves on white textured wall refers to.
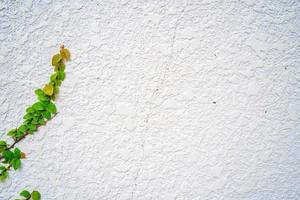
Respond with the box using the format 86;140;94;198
0;45;71;200
